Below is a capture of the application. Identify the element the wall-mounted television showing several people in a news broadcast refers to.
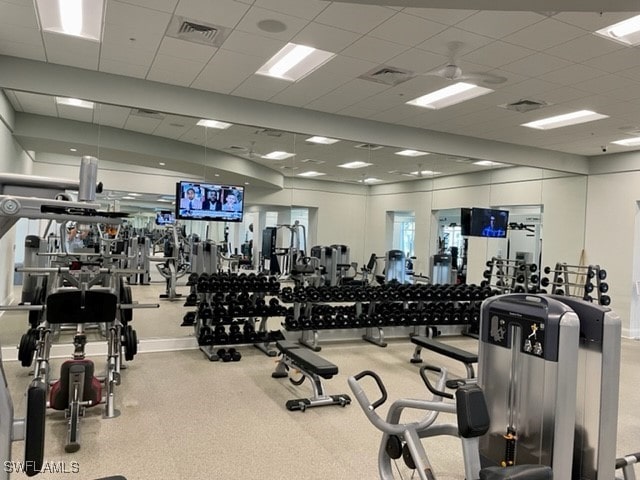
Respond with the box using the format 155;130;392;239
176;181;244;222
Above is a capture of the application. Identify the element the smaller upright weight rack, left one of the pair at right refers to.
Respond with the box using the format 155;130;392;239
481;257;540;294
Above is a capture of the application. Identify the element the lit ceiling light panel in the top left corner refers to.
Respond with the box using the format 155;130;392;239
36;0;104;42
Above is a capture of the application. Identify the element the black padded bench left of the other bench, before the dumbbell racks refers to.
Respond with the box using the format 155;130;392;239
271;340;351;412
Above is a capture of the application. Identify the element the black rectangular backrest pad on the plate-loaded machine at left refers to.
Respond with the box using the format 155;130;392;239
47;290;118;323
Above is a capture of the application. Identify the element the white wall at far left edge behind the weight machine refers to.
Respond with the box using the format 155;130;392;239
0;92;32;305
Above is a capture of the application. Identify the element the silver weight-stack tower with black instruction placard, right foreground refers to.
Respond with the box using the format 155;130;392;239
478;294;579;479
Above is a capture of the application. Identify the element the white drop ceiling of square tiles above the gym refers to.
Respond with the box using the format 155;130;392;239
0;0;640;181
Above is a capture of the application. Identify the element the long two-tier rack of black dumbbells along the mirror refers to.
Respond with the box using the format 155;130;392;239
281;284;494;352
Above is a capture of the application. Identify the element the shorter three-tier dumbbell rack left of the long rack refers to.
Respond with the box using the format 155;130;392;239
182;273;284;361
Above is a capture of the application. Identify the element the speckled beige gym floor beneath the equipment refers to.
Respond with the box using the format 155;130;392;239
4;286;640;480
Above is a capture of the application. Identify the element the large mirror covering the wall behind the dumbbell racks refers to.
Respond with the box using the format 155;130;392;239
3;91;586;344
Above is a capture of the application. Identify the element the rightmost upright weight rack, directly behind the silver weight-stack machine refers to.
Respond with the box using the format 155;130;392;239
541;262;611;306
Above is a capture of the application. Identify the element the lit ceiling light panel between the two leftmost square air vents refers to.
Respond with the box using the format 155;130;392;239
256;43;335;82
